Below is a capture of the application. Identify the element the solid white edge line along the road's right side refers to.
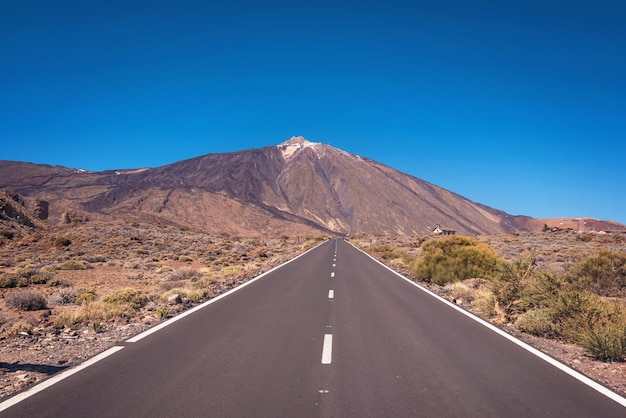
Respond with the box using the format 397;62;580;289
350;244;626;407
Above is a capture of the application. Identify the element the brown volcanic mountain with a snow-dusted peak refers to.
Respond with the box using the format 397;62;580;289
0;137;620;236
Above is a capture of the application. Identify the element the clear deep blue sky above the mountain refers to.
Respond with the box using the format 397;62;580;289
0;0;626;223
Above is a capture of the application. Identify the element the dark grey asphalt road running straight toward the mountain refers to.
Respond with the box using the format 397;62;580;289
0;240;626;417
